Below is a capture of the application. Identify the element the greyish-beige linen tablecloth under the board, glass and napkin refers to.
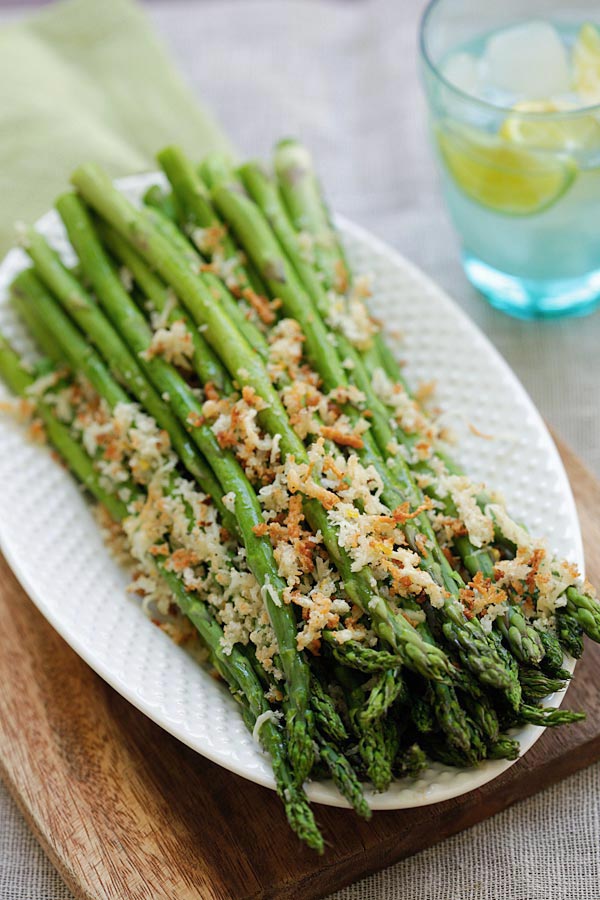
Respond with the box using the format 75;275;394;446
0;0;600;900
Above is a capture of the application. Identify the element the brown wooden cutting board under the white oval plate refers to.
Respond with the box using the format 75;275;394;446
0;432;600;900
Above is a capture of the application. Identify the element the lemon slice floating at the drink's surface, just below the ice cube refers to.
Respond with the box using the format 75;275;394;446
499;100;600;153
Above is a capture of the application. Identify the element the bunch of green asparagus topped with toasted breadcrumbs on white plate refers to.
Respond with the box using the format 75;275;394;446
0;140;600;852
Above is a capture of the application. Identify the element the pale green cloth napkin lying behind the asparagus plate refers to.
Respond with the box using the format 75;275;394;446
0;0;230;258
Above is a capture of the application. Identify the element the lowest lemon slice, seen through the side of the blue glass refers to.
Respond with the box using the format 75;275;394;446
437;124;577;216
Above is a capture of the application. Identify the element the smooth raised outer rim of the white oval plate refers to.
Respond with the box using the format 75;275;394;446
0;172;583;811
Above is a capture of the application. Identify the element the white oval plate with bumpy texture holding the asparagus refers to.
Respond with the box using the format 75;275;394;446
0;174;583;809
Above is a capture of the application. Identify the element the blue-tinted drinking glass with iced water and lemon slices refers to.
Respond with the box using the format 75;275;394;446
420;0;600;318
